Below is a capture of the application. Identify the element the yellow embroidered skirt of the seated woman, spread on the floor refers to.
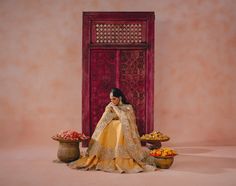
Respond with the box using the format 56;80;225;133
69;120;155;173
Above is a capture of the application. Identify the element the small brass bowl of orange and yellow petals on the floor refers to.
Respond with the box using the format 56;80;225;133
149;147;177;169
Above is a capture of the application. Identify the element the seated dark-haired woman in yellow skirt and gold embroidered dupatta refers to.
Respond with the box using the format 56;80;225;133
69;88;155;173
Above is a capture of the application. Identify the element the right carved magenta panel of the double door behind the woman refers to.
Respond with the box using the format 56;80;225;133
119;50;146;134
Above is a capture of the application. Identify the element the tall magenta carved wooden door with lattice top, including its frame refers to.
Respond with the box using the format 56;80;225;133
82;12;154;142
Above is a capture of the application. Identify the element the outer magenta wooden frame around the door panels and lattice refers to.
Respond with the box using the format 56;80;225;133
82;12;155;138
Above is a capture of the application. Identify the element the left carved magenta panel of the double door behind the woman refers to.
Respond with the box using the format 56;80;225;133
90;50;116;132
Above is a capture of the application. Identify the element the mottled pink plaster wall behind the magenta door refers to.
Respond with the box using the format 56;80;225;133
0;0;236;147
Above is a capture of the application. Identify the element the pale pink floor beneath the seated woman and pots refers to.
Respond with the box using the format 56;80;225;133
0;146;236;186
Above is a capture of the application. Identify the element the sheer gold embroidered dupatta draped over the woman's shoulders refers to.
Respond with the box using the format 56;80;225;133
88;103;145;165
